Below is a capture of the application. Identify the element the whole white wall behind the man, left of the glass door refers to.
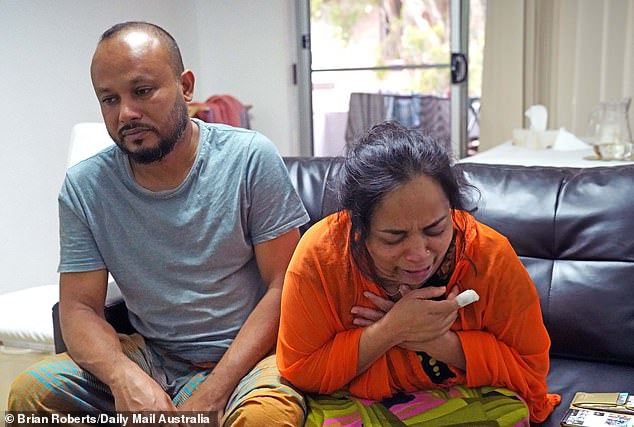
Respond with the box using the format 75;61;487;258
0;0;299;293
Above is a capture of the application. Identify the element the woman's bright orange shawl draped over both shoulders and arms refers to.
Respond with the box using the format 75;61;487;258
277;211;561;422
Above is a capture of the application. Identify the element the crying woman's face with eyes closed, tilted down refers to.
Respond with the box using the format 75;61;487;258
366;176;453;294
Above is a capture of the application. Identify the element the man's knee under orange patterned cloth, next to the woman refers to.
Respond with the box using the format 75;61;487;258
223;390;305;427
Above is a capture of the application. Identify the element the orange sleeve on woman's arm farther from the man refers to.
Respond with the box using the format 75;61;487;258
457;229;561;422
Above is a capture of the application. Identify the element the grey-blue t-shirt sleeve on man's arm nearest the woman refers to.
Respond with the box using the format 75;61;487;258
247;133;310;245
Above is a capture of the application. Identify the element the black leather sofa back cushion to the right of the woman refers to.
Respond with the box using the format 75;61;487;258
458;163;634;366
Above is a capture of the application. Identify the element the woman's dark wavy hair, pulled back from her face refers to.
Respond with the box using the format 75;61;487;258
336;121;475;278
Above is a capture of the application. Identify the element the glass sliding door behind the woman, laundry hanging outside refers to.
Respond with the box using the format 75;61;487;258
299;0;485;156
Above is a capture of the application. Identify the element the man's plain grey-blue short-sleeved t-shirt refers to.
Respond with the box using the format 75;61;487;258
58;121;308;363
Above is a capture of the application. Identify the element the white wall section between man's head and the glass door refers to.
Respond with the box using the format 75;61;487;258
195;0;299;155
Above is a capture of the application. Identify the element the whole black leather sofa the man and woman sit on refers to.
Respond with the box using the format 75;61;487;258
53;158;634;426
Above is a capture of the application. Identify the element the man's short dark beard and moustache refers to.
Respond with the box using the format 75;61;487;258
113;103;189;164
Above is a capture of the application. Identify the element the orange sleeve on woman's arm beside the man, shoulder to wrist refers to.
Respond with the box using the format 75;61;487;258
277;217;414;399
